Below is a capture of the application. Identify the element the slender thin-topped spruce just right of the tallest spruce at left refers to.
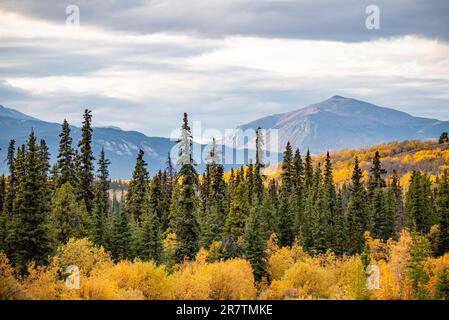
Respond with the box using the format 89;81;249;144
93;148;110;246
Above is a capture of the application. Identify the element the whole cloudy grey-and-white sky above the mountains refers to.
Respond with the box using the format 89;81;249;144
0;0;449;136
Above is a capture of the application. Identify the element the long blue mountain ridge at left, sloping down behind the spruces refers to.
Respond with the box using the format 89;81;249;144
0;106;279;179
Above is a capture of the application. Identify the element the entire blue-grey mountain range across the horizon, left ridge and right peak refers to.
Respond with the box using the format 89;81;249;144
0;96;449;179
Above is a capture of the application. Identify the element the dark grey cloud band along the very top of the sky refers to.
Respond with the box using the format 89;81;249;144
0;0;449;41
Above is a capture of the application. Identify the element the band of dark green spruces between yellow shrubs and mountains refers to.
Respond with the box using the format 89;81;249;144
0;110;449;280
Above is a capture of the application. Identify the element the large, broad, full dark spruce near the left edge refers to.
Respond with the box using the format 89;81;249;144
12;131;54;272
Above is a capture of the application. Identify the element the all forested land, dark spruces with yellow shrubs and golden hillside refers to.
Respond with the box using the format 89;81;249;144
0;110;449;299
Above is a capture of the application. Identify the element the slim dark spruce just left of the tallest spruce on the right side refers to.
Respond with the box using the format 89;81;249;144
347;157;369;254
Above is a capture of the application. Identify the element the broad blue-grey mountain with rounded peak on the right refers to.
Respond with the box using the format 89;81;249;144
225;96;449;154
